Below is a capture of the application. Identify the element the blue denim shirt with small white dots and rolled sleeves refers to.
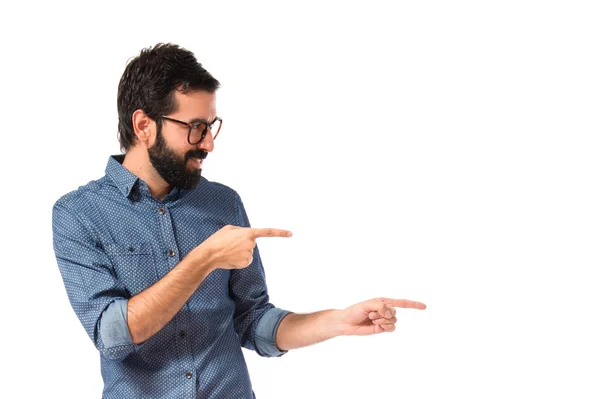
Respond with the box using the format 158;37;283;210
52;155;289;399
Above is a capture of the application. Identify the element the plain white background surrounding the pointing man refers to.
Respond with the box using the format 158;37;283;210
0;0;600;399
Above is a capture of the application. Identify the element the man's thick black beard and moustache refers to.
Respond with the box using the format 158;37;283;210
148;125;208;189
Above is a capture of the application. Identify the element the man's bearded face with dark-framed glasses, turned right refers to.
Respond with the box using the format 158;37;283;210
148;91;217;188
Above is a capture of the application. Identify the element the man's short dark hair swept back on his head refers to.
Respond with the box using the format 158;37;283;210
117;43;220;151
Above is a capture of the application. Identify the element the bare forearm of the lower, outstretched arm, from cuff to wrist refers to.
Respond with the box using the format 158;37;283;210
276;309;342;351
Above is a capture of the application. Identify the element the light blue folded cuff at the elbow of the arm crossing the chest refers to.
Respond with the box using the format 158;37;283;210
100;299;136;359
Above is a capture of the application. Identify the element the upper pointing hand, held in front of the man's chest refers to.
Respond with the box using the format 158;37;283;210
193;225;292;269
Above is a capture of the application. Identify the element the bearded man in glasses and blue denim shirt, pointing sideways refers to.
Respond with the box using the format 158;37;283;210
53;44;425;399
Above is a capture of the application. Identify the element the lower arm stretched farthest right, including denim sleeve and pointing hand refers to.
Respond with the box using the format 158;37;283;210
229;193;426;357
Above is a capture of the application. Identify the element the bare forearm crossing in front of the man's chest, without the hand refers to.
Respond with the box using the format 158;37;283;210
127;247;213;344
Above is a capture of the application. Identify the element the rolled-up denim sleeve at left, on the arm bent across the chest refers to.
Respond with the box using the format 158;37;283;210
52;203;143;360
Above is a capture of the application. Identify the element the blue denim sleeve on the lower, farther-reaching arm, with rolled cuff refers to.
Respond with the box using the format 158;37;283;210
229;193;290;357
